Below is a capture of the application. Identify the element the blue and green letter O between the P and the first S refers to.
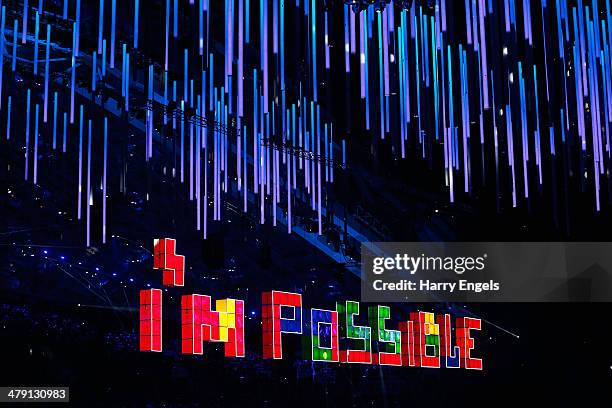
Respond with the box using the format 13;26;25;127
310;309;340;363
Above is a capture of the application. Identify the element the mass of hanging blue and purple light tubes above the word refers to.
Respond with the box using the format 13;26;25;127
0;0;612;260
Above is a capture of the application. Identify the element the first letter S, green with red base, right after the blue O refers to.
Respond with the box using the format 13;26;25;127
336;301;372;364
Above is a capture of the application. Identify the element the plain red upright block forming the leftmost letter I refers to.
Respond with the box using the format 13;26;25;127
140;289;162;352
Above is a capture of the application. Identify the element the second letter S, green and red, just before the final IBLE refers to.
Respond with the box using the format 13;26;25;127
368;306;402;366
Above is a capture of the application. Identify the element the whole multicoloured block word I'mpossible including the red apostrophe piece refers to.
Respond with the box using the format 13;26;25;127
140;238;483;370
